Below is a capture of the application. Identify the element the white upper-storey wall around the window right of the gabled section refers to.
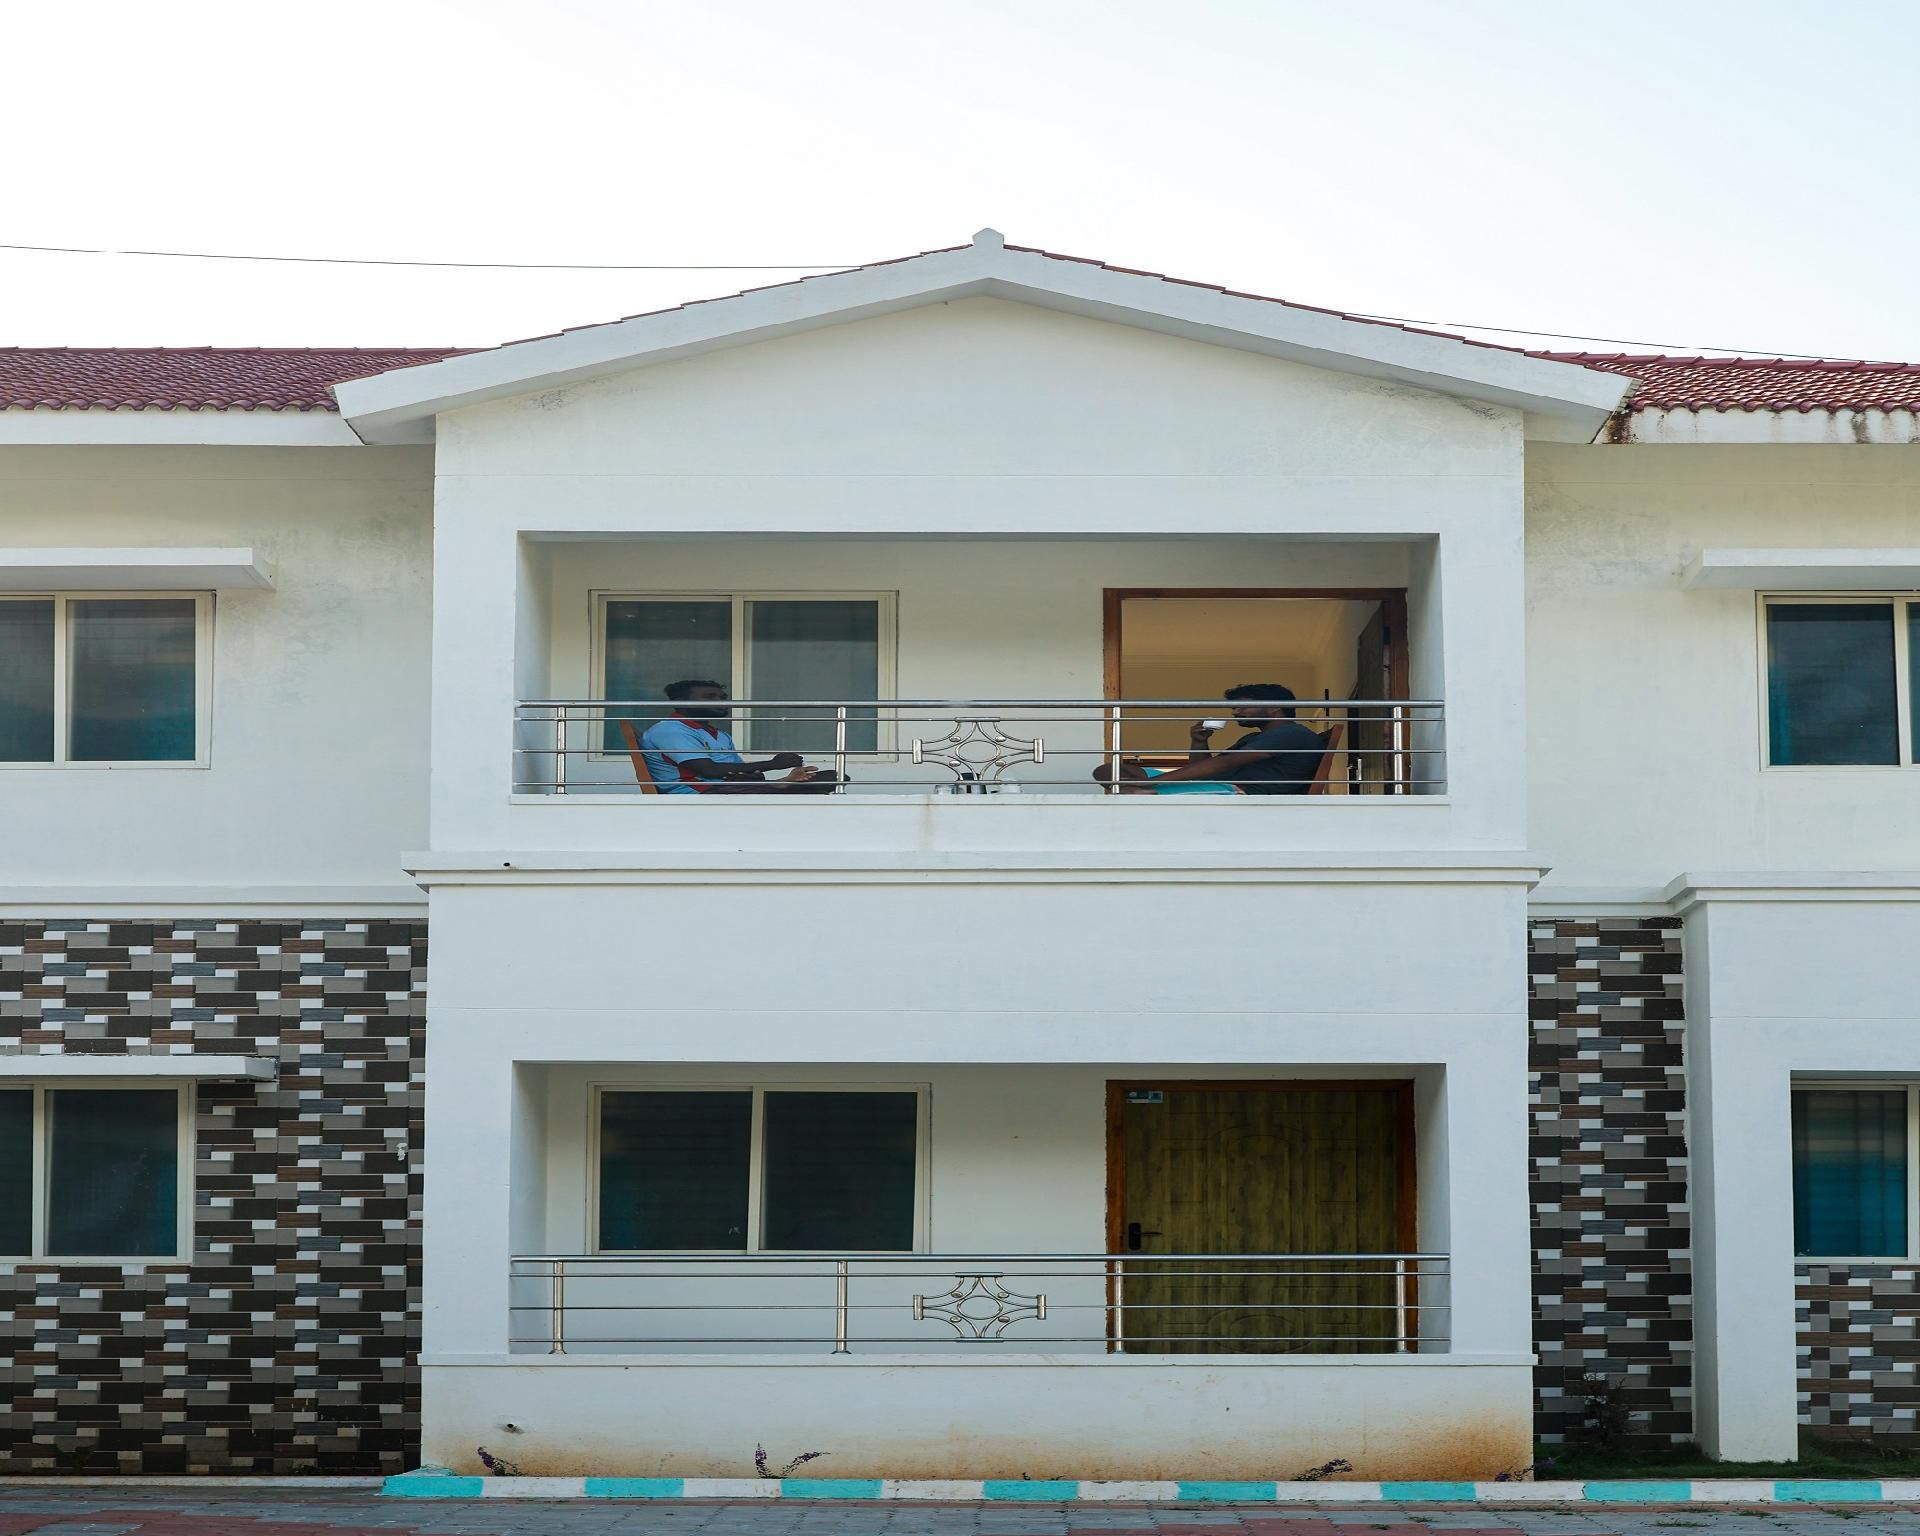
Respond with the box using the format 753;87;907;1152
1526;444;1920;897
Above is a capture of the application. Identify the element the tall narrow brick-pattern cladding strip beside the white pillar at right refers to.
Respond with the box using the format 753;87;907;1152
1528;918;1693;1444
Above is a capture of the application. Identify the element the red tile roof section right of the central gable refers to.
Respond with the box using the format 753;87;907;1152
1532;351;1920;411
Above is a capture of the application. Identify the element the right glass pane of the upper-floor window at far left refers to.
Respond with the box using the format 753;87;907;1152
67;597;194;762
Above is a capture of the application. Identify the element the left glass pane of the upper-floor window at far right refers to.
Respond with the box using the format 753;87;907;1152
1766;603;1899;764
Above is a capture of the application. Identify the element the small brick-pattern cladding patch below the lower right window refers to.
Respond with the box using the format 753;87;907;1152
1793;1263;1920;1450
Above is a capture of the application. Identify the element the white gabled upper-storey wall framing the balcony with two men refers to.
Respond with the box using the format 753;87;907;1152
434;300;1524;849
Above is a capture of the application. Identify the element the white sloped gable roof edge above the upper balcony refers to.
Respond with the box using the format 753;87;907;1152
334;230;1626;442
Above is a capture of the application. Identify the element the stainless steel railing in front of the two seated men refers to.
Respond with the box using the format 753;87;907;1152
513;699;1446;795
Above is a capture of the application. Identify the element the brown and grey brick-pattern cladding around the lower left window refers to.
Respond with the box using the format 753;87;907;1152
0;920;426;1475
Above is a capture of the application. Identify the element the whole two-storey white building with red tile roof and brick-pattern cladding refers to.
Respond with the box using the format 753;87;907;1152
0;230;1920;1478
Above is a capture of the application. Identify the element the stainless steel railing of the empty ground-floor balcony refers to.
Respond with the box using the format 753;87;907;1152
509;1254;1450;1356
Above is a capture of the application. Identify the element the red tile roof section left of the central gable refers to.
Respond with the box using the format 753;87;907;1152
0;348;461;411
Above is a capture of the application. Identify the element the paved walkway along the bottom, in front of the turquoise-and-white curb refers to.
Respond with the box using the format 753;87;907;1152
0;1486;1920;1536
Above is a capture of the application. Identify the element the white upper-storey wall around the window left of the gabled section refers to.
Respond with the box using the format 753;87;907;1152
0;447;432;898
